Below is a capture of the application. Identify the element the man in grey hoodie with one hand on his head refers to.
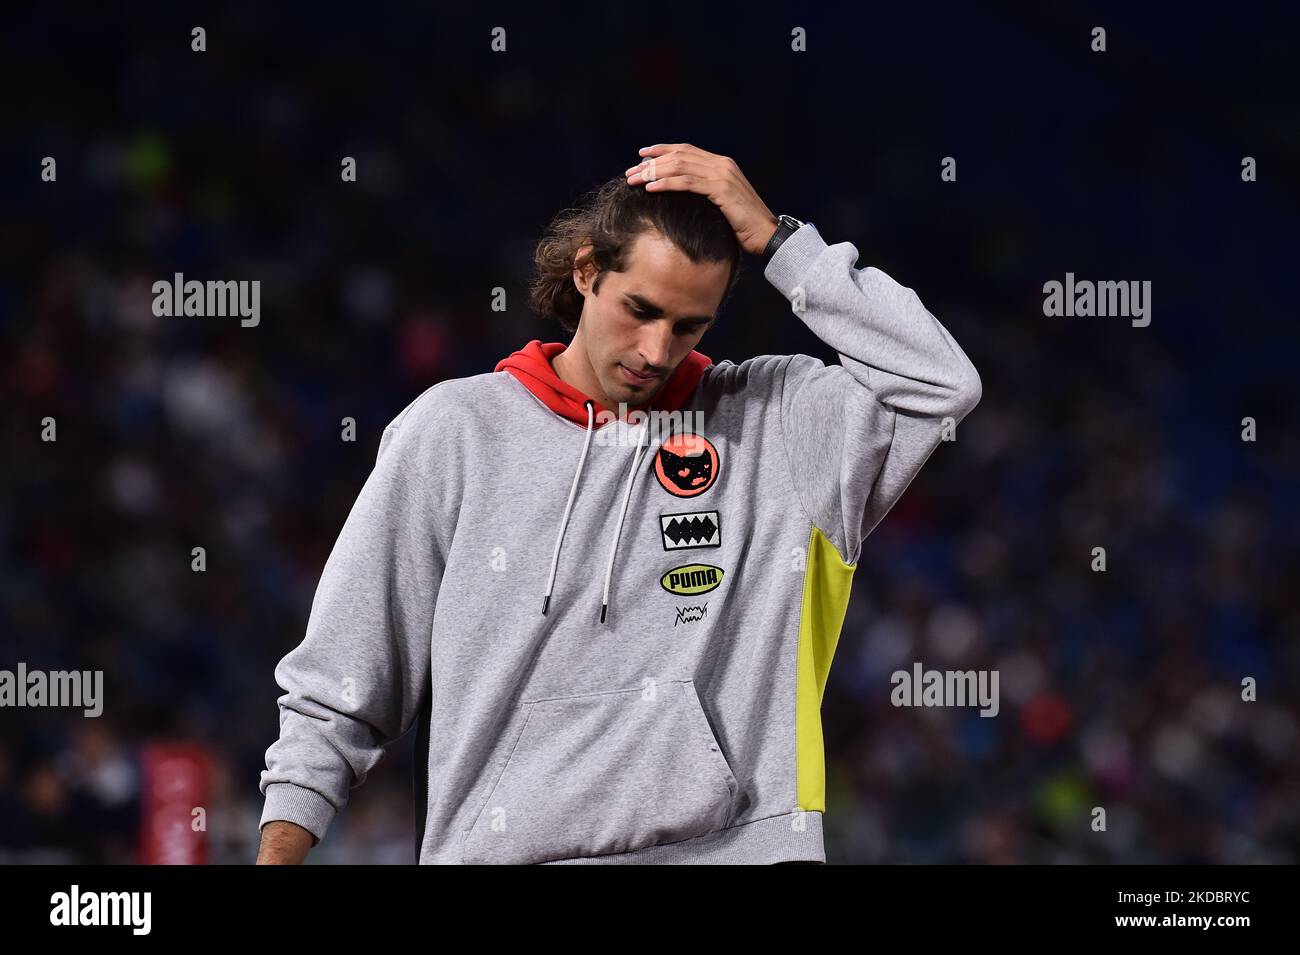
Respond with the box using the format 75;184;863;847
259;143;980;864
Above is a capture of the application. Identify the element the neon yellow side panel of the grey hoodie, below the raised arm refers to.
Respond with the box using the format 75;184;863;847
794;528;857;812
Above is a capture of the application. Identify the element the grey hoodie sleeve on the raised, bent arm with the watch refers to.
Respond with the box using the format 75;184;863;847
763;223;982;564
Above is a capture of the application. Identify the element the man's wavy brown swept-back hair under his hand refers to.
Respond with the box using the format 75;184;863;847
529;175;741;333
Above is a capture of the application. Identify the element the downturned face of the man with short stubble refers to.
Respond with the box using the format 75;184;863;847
573;231;729;409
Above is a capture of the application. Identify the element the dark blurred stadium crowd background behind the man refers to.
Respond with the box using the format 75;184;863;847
0;3;1300;863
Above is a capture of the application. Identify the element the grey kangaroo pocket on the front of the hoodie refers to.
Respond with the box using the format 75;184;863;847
462;680;738;864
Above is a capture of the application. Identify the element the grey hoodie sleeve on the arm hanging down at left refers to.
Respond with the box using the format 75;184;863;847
259;404;445;845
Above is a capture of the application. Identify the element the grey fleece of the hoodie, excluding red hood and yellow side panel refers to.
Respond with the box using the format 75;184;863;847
260;223;980;864
